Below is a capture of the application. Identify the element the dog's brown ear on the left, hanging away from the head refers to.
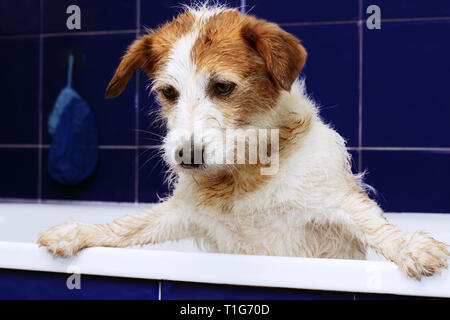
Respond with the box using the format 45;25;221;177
105;35;155;98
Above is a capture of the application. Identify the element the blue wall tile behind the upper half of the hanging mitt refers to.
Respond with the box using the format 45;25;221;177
43;34;136;145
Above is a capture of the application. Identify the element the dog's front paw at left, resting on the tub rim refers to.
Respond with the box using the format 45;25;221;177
37;222;86;257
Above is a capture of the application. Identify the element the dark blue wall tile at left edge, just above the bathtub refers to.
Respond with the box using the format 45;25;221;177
0;148;38;199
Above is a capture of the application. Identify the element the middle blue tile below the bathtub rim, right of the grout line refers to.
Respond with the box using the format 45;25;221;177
161;281;353;300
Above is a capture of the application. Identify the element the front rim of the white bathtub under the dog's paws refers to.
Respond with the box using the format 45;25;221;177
0;241;450;298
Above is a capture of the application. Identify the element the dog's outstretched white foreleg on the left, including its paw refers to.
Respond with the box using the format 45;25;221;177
38;200;190;257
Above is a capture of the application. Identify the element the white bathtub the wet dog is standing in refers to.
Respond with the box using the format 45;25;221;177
0;203;450;297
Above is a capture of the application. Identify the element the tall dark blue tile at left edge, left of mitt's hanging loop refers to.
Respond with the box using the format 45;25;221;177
0;38;39;144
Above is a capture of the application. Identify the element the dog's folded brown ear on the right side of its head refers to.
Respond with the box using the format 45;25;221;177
241;19;306;91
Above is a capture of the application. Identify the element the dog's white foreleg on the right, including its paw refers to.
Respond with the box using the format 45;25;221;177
345;197;449;280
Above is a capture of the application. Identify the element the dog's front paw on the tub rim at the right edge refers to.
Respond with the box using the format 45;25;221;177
399;232;449;280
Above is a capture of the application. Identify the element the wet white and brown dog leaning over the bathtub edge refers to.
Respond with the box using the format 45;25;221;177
38;5;449;280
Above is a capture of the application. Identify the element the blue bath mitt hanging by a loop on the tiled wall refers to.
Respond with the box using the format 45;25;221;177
48;55;98;185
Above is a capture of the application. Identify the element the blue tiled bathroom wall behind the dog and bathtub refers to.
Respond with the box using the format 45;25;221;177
0;0;450;212
